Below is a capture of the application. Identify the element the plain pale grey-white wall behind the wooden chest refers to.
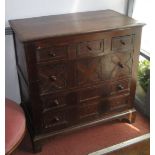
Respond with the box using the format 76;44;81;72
5;0;127;103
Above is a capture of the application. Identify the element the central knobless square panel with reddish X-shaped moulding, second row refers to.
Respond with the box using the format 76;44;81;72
76;58;102;85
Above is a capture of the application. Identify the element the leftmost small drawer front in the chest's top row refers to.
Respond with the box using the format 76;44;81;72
36;46;68;62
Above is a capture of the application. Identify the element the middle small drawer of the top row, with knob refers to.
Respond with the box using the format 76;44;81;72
77;40;104;56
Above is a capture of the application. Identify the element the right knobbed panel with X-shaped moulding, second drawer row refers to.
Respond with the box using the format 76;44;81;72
102;52;133;80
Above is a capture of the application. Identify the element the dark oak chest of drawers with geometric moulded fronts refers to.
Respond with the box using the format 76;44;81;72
10;10;144;152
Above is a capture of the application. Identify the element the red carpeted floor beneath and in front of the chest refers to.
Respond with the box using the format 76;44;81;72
13;113;149;155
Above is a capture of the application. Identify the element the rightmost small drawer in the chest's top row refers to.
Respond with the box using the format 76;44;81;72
112;35;134;52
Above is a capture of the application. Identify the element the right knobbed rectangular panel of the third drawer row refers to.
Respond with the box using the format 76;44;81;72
111;79;130;95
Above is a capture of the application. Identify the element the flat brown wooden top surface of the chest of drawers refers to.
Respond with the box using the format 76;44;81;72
9;10;143;42
